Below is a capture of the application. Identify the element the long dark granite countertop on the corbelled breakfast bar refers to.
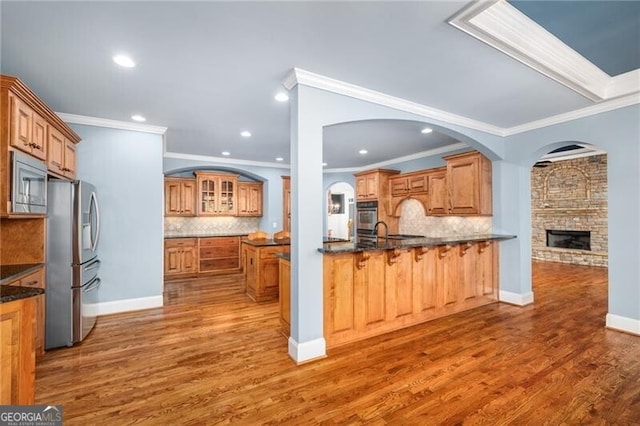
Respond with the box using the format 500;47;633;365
318;234;516;254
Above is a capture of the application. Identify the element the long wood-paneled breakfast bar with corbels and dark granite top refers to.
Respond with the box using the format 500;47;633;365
318;234;515;348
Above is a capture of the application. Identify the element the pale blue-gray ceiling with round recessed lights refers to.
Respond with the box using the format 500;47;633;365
0;1;640;169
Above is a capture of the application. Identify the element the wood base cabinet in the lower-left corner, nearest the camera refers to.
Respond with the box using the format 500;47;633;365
0;295;43;405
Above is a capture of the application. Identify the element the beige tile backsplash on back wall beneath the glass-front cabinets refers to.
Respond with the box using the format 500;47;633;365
164;216;260;237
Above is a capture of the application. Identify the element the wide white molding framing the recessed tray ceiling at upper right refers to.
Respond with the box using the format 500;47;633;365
449;0;640;102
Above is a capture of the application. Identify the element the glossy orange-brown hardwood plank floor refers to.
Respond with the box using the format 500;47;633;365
36;263;640;425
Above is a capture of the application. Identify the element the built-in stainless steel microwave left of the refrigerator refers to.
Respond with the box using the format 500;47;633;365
11;151;47;214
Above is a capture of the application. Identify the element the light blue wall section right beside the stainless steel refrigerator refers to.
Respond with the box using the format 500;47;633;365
71;125;164;302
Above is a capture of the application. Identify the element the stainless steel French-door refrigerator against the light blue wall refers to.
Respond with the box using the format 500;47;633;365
45;180;100;349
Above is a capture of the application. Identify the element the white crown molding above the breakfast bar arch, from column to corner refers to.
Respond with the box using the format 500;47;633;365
282;68;503;136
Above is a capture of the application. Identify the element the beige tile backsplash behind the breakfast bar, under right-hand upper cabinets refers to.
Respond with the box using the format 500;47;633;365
399;199;493;237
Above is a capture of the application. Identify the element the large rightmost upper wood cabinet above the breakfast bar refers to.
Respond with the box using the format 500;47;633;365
444;151;492;215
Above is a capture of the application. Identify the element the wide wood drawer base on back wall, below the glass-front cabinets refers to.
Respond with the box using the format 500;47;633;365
198;237;242;274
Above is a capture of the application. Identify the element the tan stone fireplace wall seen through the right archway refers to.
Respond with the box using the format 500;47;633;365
531;154;609;266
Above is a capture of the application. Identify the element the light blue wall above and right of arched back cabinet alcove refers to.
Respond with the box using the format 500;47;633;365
163;157;290;233
